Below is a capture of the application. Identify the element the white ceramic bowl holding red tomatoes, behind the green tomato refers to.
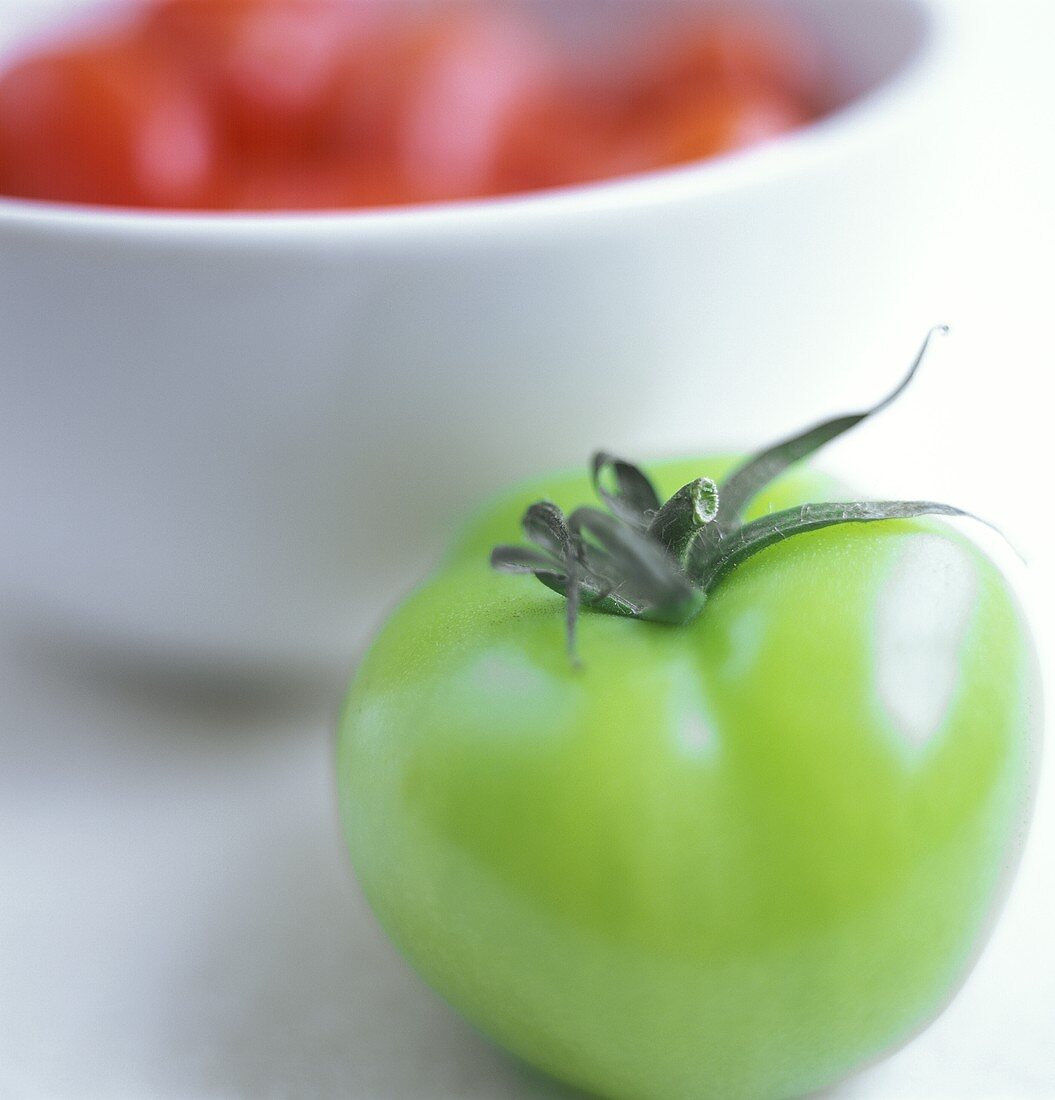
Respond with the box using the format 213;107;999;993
0;0;955;670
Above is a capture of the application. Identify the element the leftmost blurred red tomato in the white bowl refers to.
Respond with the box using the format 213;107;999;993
0;44;217;208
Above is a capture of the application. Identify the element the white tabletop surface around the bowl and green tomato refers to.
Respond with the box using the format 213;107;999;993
0;0;1055;1100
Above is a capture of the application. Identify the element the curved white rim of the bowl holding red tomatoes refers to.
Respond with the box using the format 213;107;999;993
0;0;956;244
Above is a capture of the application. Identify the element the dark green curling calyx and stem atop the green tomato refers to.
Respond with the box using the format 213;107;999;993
491;325;990;660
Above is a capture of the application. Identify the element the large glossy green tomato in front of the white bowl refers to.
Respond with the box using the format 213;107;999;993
339;451;1040;1100
